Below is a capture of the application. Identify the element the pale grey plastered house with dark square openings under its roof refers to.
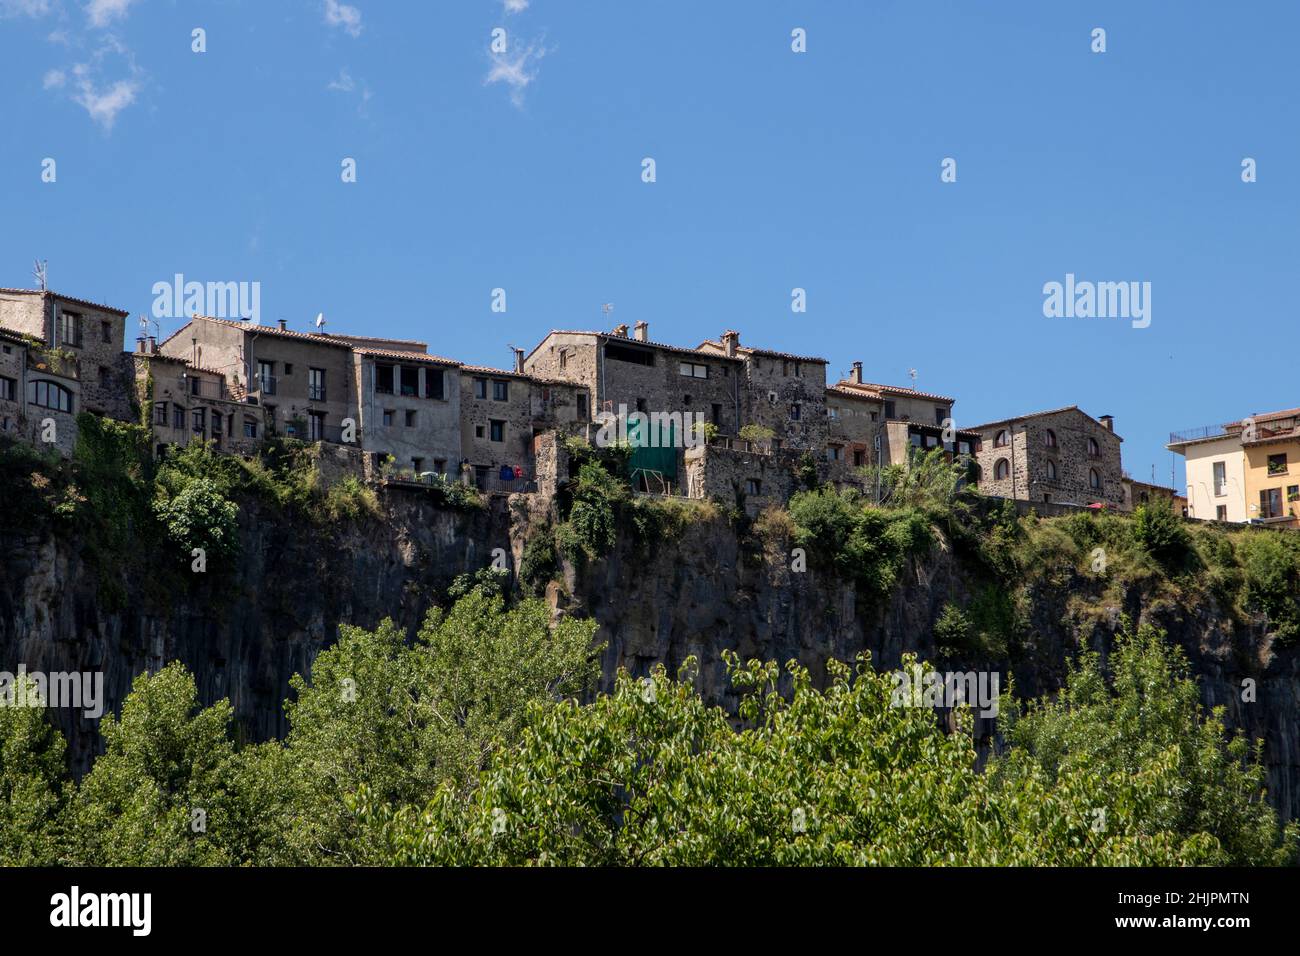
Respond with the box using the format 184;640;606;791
351;341;462;476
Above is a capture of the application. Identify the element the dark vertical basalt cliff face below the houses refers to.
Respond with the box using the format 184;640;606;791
0;490;1300;818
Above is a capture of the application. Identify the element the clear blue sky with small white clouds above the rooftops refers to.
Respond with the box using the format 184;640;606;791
0;0;1300;485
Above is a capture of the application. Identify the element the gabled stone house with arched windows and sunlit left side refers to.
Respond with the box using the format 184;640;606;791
974;405;1125;509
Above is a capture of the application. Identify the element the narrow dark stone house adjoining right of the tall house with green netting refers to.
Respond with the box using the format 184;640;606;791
697;329;827;453
